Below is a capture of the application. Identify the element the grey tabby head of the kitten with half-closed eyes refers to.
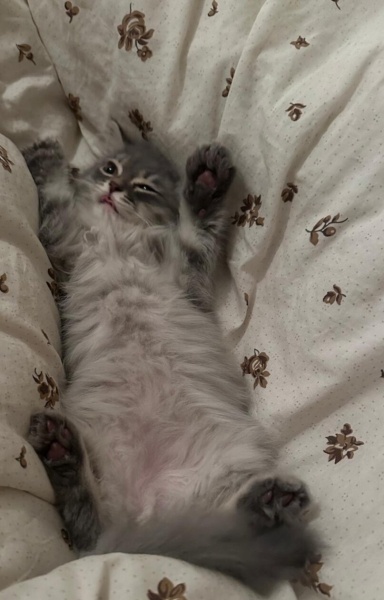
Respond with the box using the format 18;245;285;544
81;137;180;225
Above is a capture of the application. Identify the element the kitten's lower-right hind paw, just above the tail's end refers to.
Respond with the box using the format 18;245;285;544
239;478;310;526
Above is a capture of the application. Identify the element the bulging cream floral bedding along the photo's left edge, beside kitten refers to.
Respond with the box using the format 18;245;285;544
0;136;73;587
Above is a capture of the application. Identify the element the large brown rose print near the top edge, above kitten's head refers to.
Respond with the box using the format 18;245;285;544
117;5;155;62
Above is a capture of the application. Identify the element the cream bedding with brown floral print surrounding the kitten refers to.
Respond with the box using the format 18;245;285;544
0;0;384;600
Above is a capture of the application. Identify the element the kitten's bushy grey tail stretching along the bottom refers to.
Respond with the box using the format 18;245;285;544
96;513;319;593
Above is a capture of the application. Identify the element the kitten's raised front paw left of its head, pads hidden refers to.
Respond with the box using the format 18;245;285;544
22;139;65;185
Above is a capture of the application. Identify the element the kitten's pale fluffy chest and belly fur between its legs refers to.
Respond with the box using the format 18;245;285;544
63;227;271;521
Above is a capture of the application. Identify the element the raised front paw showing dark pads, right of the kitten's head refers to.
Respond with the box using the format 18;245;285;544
184;144;235;216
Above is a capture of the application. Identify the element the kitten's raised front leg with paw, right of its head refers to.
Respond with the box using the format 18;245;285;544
180;144;235;310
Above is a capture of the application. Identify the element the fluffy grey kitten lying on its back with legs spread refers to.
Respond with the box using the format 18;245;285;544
25;140;319;591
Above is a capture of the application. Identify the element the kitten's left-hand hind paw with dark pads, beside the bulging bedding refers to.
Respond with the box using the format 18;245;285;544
28;412;83;485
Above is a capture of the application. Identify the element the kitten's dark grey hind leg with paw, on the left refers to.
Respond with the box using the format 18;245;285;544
28;412;100;551
